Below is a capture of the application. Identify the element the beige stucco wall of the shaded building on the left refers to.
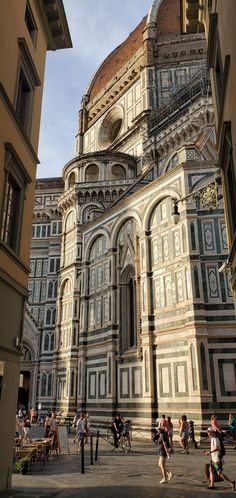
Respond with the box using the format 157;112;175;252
0;0;71;490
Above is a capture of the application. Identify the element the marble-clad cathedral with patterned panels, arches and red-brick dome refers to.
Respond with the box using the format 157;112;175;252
22;0;236;429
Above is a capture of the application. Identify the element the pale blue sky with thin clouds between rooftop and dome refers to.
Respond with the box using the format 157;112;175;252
37;0;152;178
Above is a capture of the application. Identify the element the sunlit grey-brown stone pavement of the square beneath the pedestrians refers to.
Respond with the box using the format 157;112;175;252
0;435;236;498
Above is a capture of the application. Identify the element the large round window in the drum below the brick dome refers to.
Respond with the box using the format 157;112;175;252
99;106;123;149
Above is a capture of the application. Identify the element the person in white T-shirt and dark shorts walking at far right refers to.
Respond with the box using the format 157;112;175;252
204;427;235;490
